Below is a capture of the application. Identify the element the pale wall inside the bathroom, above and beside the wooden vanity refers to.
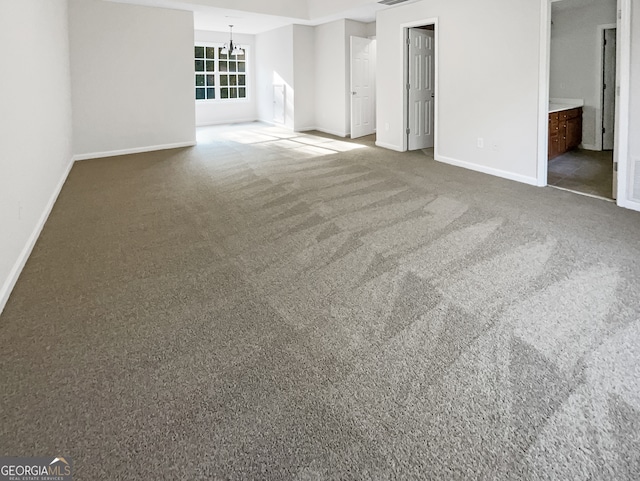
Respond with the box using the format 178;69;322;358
549;0;617;150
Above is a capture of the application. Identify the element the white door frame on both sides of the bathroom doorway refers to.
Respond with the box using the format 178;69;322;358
537;0;640;210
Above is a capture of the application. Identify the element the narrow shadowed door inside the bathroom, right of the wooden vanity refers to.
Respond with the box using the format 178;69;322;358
602;28;616;150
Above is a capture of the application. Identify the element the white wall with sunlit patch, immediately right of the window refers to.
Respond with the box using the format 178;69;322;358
256;25;295;130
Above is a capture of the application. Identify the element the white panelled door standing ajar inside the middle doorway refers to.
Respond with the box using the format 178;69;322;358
407;28;435;150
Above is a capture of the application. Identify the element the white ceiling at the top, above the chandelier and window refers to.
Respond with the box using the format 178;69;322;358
107;0;392;34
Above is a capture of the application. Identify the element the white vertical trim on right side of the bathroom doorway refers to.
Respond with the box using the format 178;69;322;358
613;0;640;204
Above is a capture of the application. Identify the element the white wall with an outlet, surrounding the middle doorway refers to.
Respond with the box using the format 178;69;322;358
377;0;541;184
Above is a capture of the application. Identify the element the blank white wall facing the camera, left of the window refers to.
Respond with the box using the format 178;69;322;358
69;0;195;158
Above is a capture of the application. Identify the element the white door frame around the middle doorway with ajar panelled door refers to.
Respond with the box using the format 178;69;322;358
400;17;440;153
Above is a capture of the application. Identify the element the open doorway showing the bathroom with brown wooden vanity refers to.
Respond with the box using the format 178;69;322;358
547;0;617;200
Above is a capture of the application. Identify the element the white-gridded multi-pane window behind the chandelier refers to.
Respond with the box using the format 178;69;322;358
194;45;247;100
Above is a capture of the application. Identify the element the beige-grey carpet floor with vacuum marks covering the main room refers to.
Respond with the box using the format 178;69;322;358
0;124;640;481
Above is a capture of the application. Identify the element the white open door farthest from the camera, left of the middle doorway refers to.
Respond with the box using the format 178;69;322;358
351;37;376;139
